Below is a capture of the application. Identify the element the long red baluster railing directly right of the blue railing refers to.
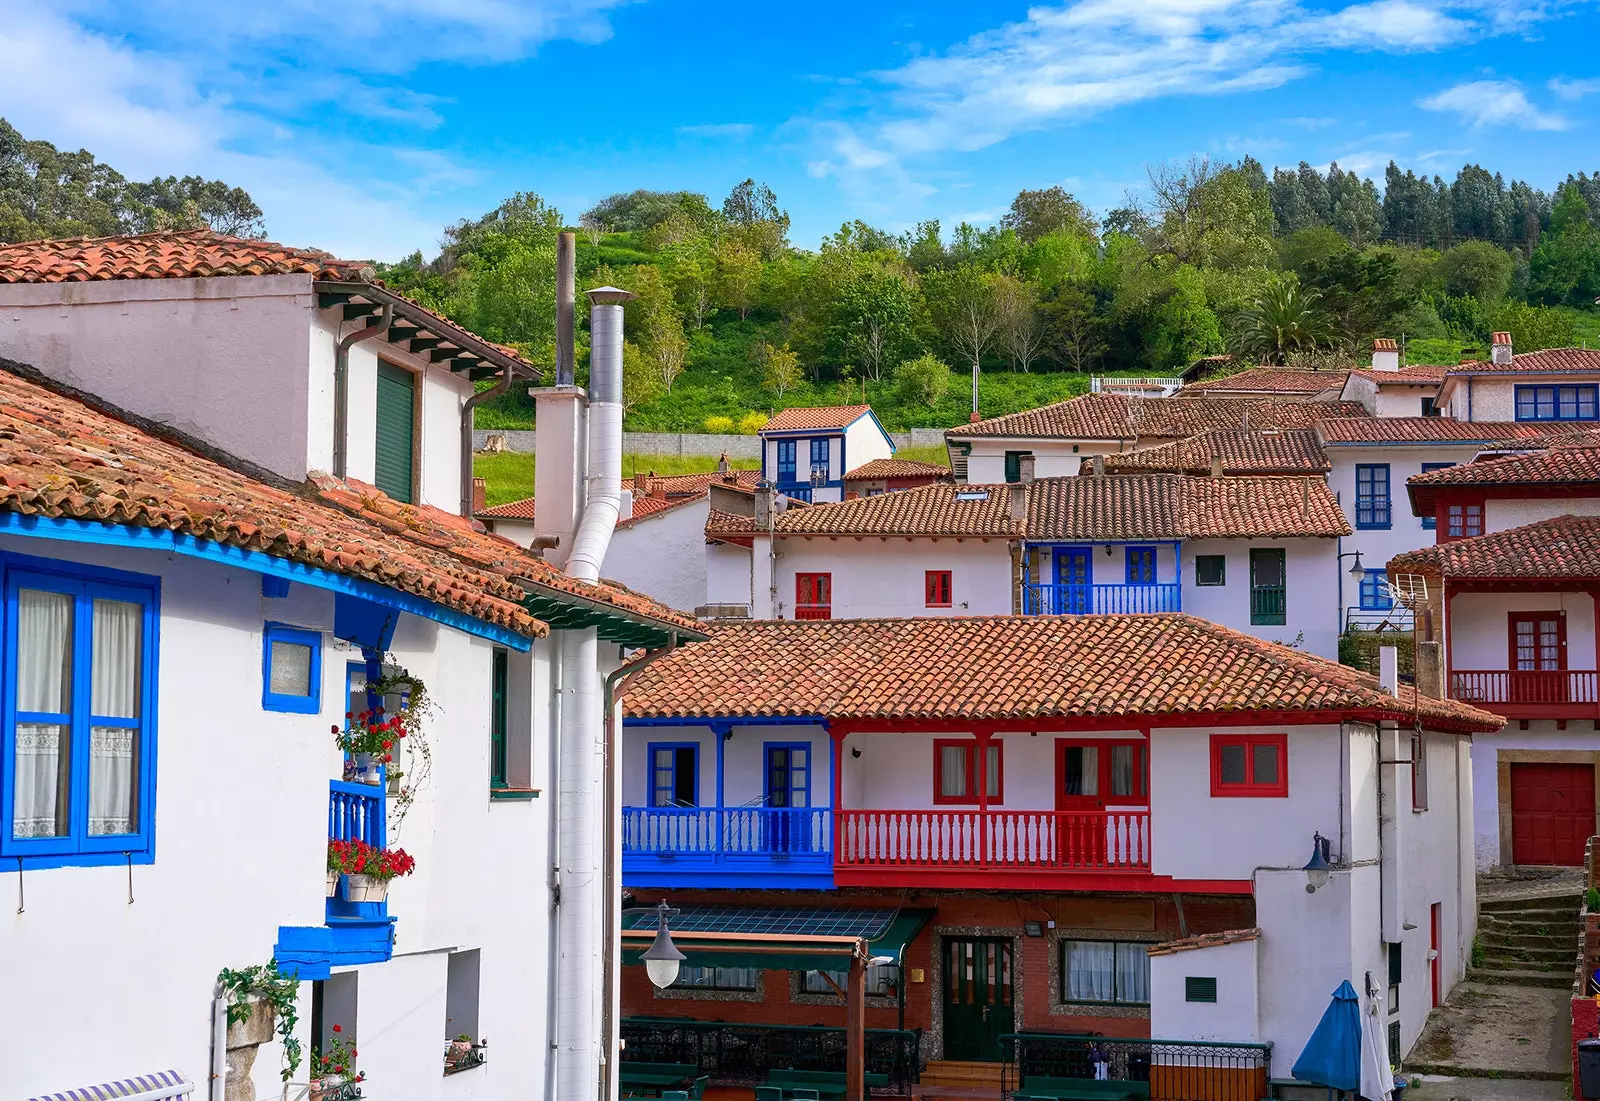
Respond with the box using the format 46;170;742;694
834;810;1150;871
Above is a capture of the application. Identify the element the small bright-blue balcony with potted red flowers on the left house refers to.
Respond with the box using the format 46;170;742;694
274;779;395;979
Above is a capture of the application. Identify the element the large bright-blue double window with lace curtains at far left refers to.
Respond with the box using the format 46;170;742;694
0;557;160;867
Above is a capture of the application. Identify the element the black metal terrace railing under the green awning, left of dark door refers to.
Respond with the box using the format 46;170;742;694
621;1016;922;1095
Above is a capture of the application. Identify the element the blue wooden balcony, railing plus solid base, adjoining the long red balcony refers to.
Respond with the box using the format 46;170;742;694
622;807;834;890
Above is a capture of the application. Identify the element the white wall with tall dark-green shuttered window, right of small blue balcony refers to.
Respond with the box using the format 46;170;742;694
1182;539;1350;658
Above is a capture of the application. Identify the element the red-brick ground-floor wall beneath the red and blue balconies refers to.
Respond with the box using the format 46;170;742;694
622;888;1256;1058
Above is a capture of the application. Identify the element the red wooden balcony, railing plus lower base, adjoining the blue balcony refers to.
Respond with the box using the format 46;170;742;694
834;810;1150;888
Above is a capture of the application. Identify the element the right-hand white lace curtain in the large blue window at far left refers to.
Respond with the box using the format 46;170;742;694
90;600;144;835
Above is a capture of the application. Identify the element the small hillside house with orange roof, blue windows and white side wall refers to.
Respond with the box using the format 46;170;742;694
760;405;894;501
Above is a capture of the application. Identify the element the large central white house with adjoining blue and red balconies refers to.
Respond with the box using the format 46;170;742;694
622;615;1501;1096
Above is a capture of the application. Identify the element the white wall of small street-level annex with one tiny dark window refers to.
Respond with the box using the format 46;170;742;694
1150;941;1261;1043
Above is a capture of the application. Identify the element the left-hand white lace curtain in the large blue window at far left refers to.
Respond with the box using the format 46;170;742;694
11;589;72;837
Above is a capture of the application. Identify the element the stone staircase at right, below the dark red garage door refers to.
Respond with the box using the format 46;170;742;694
1467;893;1582;989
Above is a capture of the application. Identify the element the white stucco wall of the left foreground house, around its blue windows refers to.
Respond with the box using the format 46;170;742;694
0;536;554;1099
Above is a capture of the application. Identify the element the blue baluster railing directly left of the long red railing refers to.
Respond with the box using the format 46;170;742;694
622;807;834;856
